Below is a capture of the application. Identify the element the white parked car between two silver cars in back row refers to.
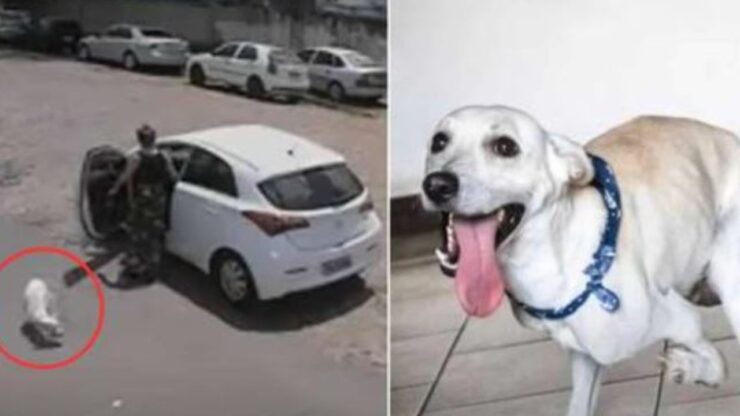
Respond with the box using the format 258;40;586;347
186;42;309;101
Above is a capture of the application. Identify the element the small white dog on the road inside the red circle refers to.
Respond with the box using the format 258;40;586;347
23;278;64;341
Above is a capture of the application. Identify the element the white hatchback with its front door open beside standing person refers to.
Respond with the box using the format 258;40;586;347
78;125;381;304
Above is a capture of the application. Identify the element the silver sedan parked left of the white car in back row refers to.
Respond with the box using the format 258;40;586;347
77;24;188;70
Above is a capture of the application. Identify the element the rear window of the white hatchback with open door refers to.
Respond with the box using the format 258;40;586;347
259;164;363;211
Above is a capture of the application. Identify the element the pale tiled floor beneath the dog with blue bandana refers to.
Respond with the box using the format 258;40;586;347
391;260;740;416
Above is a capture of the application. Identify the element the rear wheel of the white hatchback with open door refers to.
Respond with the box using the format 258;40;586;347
213;252;257;307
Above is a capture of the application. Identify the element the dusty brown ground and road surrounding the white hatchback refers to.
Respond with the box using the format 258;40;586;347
0;49;387;415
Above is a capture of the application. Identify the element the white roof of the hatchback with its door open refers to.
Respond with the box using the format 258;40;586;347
161;124;345;179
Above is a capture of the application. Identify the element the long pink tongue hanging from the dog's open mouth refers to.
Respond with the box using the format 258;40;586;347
454;215;504;317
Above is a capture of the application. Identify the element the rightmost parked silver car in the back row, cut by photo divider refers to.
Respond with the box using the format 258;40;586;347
298;47;388;101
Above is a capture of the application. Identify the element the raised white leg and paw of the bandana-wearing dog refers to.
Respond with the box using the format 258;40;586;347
653;290;725;386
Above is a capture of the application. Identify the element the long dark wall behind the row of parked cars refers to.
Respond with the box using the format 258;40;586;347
24;0;386;58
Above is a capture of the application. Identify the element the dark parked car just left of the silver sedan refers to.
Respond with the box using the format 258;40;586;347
28;16;82;54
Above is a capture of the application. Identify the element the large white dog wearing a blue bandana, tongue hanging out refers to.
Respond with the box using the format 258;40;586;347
423;106;740;416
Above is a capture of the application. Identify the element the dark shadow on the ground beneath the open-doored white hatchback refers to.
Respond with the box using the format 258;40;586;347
64;244;374;332
